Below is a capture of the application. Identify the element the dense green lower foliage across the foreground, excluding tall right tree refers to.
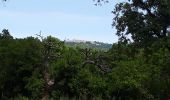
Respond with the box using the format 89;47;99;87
0;30;170;100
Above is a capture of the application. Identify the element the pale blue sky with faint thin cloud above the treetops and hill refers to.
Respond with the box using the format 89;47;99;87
0;0;120;43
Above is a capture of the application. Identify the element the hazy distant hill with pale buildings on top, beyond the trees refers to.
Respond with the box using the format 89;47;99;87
65;40;112;51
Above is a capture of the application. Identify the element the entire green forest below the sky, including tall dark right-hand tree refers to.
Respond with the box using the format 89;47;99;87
0;0;170;100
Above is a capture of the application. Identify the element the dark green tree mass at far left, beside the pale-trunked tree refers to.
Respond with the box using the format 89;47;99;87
0;34;41;100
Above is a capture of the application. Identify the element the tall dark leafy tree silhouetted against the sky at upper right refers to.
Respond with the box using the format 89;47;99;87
113;0;170;46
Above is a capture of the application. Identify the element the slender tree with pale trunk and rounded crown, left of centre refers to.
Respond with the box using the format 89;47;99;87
38;36;64;100
